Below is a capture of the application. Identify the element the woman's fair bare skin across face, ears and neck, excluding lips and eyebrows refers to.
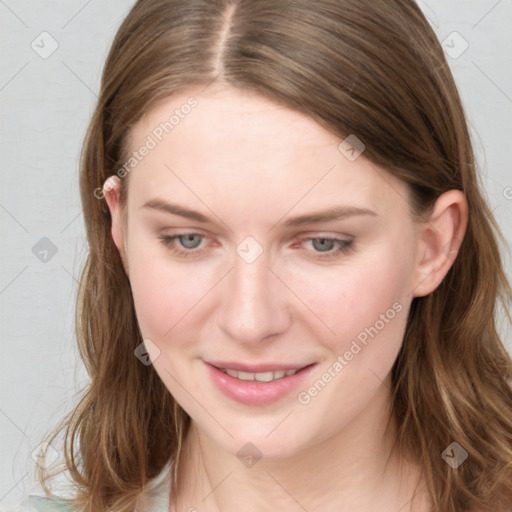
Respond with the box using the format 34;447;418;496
105;87;467;512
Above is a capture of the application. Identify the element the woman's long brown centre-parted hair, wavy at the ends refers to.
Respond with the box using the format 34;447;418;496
40;0;512;512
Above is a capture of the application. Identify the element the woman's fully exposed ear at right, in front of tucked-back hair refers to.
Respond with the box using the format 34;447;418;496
412;190;468;297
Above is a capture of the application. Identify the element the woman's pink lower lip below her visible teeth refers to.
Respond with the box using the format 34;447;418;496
206;363;316;405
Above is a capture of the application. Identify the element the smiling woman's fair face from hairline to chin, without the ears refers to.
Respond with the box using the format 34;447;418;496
109;89;424;457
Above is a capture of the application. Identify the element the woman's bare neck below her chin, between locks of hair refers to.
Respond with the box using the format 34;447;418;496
171;376;428;512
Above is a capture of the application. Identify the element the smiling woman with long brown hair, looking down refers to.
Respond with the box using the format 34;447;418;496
23;0;512;512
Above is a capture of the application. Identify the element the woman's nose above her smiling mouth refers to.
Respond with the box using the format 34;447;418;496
218;247;291;345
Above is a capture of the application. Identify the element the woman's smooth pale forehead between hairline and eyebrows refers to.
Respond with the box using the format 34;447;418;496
129;89;406;222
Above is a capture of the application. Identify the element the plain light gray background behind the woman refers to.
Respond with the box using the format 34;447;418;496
0;0;512;510
